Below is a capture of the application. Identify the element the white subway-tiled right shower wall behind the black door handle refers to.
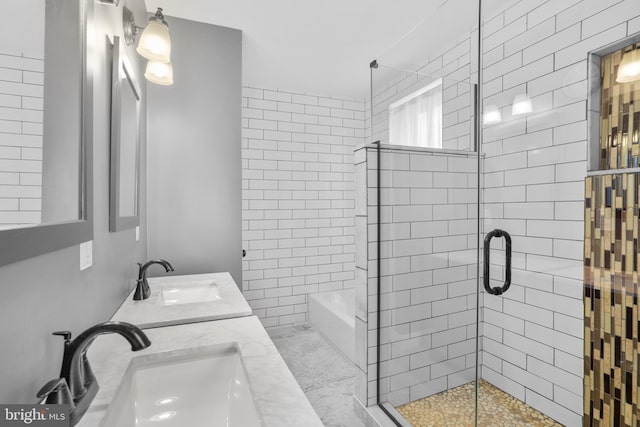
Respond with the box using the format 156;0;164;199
482;0;640;426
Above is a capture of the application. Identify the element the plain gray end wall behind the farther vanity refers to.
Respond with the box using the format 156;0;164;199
147;18;242;286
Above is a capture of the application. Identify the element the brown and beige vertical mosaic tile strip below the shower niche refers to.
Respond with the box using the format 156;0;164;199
583;173;640;427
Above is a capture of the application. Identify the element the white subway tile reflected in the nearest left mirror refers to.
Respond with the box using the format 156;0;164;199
0;53;44;229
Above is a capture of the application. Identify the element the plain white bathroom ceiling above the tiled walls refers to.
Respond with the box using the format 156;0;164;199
146;0;505;98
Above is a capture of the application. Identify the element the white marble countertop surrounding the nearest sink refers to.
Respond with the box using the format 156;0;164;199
78;316;322;427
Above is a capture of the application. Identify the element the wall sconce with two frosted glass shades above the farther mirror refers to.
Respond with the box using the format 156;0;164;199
122;7;173;85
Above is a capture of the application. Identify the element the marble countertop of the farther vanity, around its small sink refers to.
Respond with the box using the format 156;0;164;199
111;273;253;329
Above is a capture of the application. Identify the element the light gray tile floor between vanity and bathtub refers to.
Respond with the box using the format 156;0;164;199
268;325;364;427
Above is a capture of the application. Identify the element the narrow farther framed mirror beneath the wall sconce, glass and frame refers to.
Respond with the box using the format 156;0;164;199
109;37;141;231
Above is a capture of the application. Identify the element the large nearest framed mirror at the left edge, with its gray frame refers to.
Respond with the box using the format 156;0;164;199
0;0;93;265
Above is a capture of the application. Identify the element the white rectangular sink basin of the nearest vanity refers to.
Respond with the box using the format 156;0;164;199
103;343;262;427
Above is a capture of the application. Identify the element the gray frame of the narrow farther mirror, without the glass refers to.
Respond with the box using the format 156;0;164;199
109;36;142;232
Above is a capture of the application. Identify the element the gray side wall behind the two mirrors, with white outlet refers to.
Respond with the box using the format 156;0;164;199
0;0;146;403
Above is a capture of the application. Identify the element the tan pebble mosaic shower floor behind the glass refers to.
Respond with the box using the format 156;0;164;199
398;380;562;427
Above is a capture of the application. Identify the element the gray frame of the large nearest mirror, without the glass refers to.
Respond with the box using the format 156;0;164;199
0;0;93;266
